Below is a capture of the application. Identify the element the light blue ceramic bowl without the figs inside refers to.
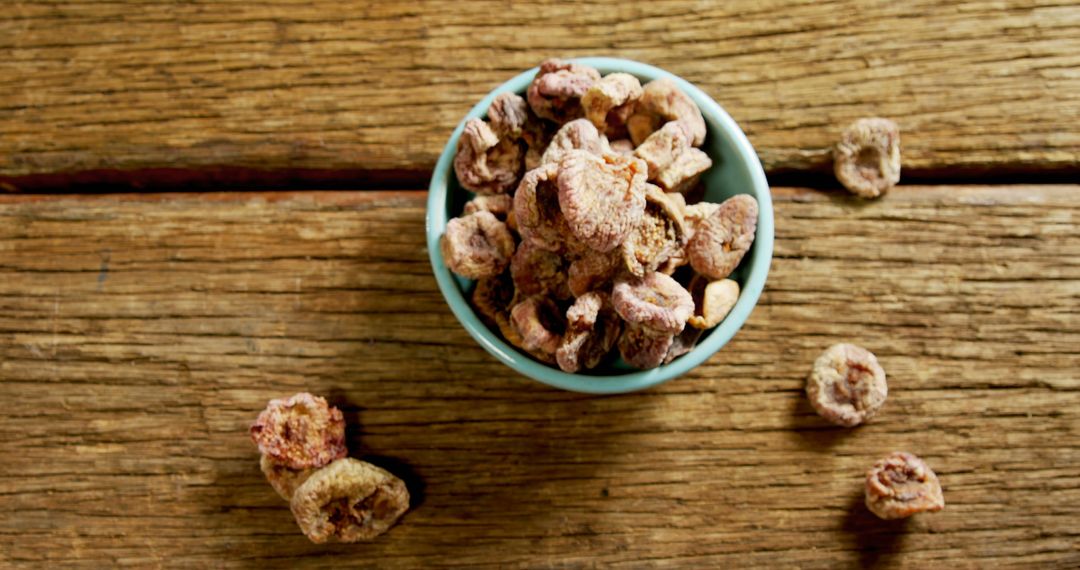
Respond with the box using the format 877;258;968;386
428;57;773;394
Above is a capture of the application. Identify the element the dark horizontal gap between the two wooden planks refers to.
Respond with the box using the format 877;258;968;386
0;164;1080;194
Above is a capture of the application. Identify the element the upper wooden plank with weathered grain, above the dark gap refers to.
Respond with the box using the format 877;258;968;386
0;0;1080;184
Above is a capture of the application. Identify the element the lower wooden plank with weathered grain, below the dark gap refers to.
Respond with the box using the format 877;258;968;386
0;186;1080;568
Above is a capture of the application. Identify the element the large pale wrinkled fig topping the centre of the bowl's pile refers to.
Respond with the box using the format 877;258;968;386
558;150;645;253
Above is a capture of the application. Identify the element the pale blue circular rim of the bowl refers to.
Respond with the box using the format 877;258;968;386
424;57;773;394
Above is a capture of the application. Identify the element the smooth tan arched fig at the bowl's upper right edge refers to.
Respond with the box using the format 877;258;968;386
627;78;705;147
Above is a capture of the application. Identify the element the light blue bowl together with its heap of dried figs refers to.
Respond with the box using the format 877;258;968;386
427;57;773;394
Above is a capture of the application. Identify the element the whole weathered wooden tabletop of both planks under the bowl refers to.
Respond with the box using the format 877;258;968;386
0;0;1080;568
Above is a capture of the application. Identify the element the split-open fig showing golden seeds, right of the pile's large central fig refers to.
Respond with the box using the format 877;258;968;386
620;184;687;277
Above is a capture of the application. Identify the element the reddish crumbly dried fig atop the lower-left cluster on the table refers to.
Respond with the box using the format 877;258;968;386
251;392;347;470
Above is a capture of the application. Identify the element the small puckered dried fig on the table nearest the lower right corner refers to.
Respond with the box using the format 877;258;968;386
866;451;945;519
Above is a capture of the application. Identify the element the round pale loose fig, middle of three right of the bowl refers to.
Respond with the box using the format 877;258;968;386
807;343;889;428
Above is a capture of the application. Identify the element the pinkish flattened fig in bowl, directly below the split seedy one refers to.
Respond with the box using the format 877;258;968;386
611;272;693;334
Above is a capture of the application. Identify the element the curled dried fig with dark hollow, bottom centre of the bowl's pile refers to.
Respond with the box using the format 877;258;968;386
555;291;622;374
